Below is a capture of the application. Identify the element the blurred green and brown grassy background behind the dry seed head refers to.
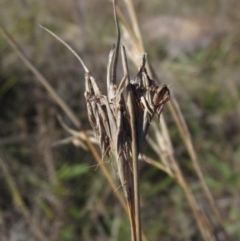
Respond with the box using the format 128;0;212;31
0;0;240;241
